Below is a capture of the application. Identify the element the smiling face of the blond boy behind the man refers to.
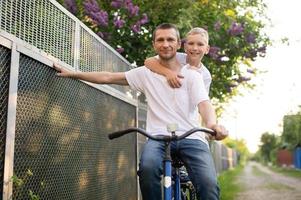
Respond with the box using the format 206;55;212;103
184;34;210;60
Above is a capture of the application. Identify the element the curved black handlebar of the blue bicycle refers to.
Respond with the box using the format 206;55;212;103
108;127;216;142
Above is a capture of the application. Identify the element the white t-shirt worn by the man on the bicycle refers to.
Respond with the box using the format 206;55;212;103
125;66;209;143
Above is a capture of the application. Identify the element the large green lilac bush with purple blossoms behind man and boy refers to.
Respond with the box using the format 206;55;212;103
60;0;271;105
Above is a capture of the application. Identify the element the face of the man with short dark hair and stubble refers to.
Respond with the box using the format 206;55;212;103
153;28;181;60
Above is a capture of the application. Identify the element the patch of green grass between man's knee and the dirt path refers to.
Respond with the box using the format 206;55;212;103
218;166;243;200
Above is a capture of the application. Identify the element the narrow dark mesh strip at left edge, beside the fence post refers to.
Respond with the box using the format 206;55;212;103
0;46;11;199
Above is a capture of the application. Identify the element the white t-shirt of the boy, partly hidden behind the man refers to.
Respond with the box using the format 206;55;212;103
176;52;212;94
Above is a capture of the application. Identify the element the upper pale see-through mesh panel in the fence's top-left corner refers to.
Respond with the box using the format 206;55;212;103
0;0;75;65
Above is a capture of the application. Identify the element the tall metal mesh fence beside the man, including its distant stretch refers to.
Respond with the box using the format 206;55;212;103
0;0;237;200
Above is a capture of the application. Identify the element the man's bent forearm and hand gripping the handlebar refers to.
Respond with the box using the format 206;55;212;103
198;100;228;140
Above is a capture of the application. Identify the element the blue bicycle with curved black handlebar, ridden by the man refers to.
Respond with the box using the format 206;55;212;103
108;125;216;200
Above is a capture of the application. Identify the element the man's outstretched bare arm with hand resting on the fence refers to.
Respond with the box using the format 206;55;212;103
53;64;128;85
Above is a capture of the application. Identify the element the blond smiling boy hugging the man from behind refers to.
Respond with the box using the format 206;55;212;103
144;27;212;93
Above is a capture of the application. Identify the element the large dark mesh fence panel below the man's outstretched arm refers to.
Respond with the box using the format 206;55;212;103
13;55;137;200
